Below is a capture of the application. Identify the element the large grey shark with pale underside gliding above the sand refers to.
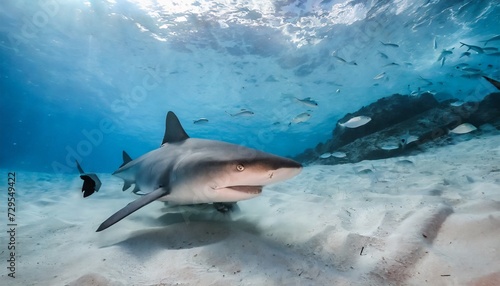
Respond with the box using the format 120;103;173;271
94;111;302;232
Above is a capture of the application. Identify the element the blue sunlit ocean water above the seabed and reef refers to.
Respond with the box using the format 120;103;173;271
0;0;500;174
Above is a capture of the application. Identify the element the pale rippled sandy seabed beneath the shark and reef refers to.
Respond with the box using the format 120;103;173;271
0;131;500;285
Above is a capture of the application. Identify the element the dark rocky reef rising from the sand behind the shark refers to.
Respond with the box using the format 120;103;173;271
294;93;500;164
